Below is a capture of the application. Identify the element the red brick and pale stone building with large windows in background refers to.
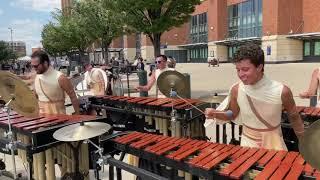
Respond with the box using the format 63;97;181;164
111;0;320;63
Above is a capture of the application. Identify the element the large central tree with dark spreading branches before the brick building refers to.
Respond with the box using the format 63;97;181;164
110;0;201;56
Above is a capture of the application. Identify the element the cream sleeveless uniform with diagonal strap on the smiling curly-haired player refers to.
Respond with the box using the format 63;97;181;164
205;76;287;150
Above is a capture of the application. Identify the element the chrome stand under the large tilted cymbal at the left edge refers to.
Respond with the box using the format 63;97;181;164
4;96;17;179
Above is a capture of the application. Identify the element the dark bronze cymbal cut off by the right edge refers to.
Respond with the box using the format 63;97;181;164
299;120;320;170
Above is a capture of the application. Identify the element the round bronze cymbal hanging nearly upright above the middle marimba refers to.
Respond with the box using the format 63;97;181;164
157;71;188;98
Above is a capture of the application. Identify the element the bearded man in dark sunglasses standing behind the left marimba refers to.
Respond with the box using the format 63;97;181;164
31;51;80;114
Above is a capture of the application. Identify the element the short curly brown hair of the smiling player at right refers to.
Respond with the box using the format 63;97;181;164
233;43;264;70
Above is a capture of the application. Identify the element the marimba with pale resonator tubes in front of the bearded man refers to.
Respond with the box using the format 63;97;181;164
0;112;102;180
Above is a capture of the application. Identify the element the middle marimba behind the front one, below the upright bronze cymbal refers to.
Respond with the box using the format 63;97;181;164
89;96;210;137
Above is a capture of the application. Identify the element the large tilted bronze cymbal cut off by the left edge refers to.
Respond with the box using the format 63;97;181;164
0;71;39;117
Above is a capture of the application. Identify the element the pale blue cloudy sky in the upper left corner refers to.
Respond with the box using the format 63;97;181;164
0;0;61;55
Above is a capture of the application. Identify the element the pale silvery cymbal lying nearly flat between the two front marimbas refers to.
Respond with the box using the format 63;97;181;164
53;122;111;142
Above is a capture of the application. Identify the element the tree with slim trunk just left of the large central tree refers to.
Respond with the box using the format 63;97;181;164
72;0;124;63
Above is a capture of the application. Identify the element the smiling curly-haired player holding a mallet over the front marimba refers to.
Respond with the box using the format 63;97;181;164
205;43;304;150
